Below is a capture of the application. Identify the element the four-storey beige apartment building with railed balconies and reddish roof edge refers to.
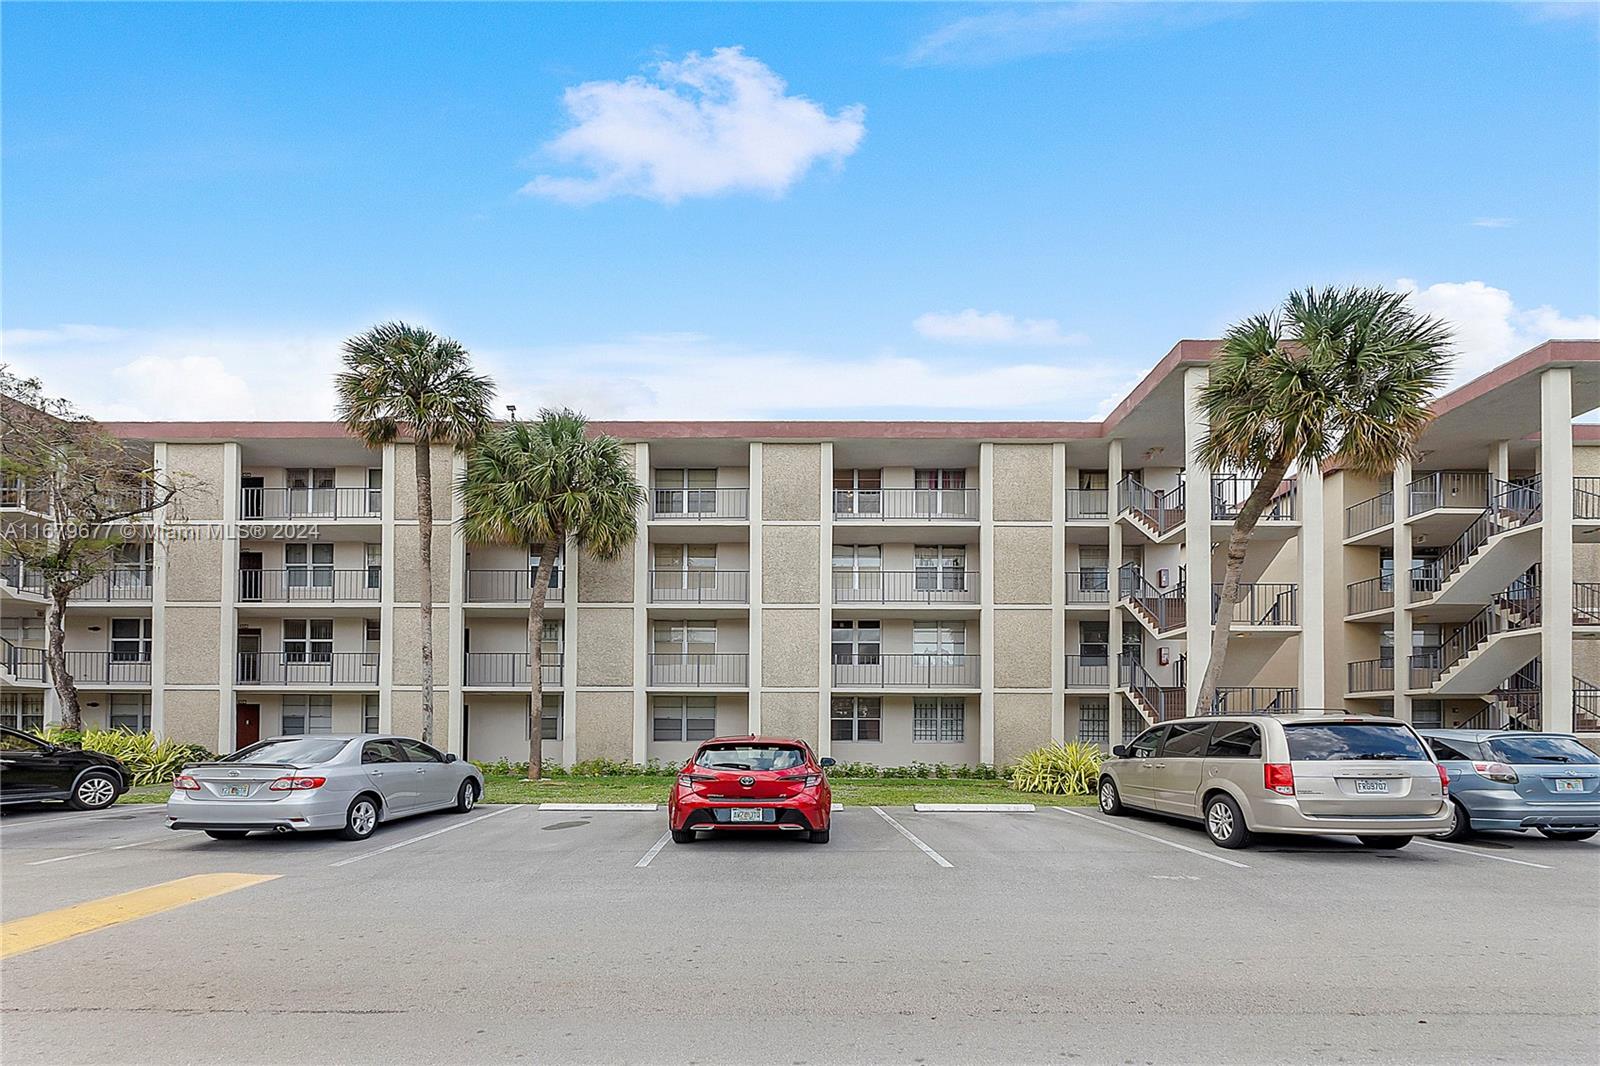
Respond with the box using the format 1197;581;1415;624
0;341;1600;765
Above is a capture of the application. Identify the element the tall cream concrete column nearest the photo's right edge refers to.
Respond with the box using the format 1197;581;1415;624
1539;367;1573;733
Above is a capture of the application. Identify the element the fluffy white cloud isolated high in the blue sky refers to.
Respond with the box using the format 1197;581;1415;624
523;46;866;203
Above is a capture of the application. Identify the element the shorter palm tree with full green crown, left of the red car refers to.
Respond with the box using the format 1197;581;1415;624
459;410;645;781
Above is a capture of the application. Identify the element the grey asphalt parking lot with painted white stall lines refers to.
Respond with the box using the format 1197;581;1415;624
0;805;1600;1063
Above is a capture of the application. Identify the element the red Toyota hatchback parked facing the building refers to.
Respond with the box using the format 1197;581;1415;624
667;736;834;844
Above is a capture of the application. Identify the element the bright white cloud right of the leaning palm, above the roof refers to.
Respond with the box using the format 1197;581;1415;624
1395;277;1600;386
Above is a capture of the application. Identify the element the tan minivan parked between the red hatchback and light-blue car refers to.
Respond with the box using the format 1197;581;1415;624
1099;714;1450;848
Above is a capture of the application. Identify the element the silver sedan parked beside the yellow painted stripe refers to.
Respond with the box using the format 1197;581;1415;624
166;733;483;840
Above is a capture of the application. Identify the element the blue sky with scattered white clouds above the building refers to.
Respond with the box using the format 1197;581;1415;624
0;3;1600;418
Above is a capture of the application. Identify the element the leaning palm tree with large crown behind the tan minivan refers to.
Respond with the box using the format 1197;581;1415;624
1195;287;1451;714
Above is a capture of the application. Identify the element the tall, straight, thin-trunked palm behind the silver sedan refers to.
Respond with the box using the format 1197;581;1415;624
334;322;494;743
